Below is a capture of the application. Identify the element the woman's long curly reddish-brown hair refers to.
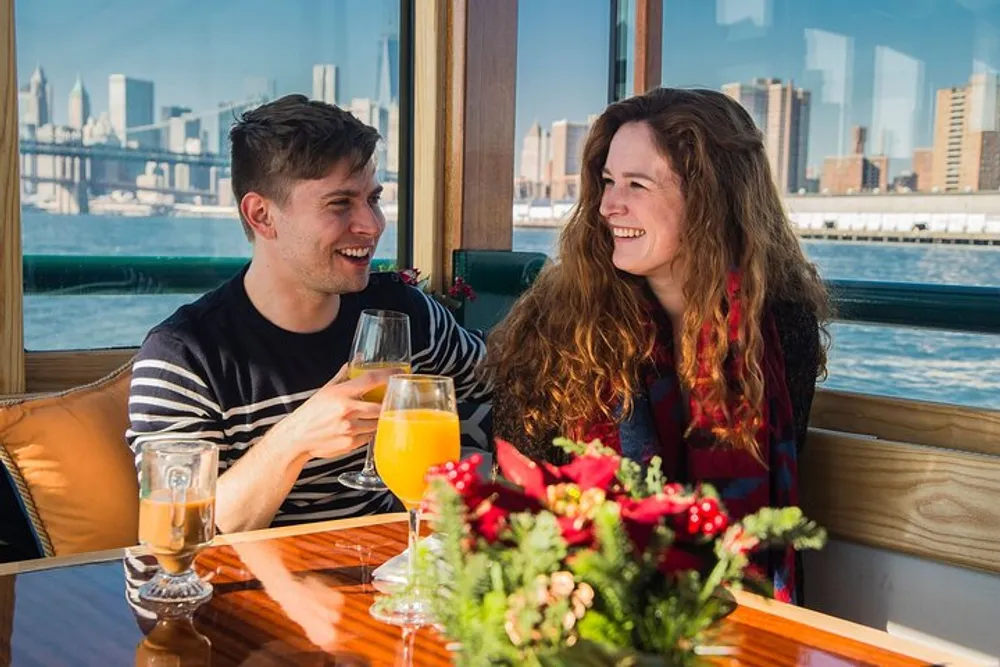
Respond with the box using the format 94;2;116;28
486;88;829;453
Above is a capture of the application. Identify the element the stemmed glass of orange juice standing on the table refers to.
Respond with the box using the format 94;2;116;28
371;375;461;625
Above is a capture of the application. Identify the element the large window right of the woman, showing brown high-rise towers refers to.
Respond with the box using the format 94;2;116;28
663;0;1000;408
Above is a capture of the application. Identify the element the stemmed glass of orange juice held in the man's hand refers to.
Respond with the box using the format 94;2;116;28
338;309;410;491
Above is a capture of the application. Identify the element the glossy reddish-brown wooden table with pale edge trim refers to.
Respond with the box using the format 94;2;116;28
0;515;959;667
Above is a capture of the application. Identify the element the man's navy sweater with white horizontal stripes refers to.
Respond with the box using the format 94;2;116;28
126;268;490;526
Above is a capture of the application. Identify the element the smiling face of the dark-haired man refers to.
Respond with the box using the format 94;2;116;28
258;160;385;294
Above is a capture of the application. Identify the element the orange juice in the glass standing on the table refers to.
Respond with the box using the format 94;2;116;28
375;409;461;509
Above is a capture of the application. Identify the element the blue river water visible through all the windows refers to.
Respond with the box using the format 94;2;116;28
23;212;1000;409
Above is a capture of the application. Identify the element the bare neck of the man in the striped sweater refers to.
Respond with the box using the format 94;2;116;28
243;257;340;333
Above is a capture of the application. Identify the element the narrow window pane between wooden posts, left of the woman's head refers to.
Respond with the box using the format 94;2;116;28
513;0;608;254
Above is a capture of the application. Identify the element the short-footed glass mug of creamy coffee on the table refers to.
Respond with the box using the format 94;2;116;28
139;441;219;614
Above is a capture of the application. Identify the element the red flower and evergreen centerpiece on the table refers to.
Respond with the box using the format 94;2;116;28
390;439;826;666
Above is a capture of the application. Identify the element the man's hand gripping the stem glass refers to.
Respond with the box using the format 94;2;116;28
275;365;399;459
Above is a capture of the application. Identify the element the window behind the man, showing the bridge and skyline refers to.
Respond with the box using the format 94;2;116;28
15;0;408;350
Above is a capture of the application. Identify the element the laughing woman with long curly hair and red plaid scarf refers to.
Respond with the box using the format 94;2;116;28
487;89;828;600
